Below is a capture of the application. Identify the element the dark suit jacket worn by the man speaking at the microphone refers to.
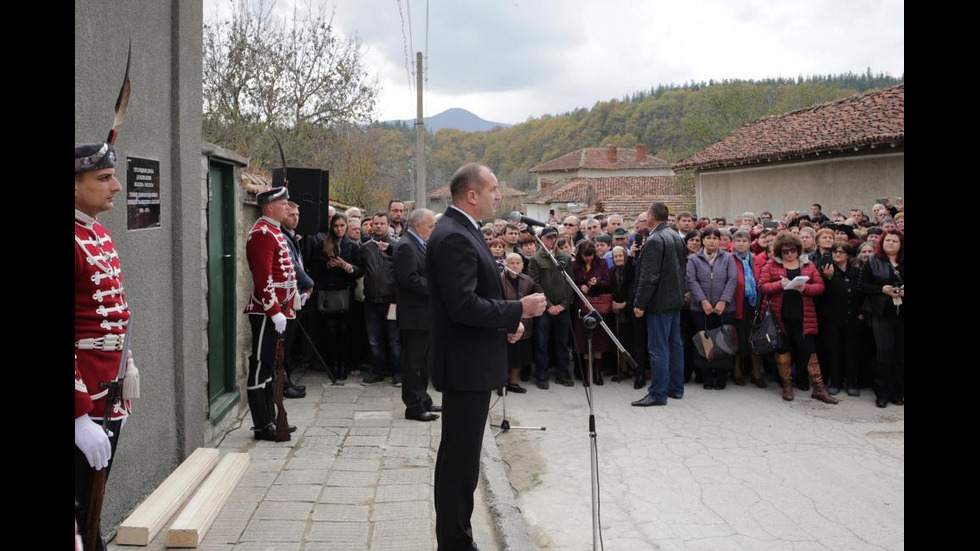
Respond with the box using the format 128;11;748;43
426;208;522;392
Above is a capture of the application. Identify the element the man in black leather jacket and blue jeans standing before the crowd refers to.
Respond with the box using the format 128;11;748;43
633;202;687;407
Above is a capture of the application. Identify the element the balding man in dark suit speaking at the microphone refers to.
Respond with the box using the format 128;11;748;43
426;163;545;551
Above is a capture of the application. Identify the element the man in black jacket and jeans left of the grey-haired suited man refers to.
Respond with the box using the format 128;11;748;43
357;211;402;386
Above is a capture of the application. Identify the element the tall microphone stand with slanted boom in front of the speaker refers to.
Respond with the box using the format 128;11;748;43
531;225;637;551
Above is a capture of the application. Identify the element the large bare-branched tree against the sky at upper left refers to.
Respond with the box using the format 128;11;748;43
204;0;378;157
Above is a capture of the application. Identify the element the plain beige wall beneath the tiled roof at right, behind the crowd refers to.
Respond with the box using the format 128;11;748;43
695;151;905;220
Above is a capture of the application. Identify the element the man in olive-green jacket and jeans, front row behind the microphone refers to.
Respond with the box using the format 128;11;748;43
528;227;575;390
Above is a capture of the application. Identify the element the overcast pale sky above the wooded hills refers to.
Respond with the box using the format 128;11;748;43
205;0;905;123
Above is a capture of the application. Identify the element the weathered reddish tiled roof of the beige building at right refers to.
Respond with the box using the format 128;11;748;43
674;84;905;170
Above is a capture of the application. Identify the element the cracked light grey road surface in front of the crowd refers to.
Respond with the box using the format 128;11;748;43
491;379;905;551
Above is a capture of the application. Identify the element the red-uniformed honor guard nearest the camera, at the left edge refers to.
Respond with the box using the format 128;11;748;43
75;142;137;548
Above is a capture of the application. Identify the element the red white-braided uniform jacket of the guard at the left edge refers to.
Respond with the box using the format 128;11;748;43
75;210;130;420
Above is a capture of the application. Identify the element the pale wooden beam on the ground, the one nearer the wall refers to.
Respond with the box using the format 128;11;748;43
115;448;221;545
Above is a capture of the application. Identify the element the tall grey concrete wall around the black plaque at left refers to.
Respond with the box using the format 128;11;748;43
75;0;207;528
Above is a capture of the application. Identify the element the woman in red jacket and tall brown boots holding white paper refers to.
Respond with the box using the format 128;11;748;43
759;231;837;404
